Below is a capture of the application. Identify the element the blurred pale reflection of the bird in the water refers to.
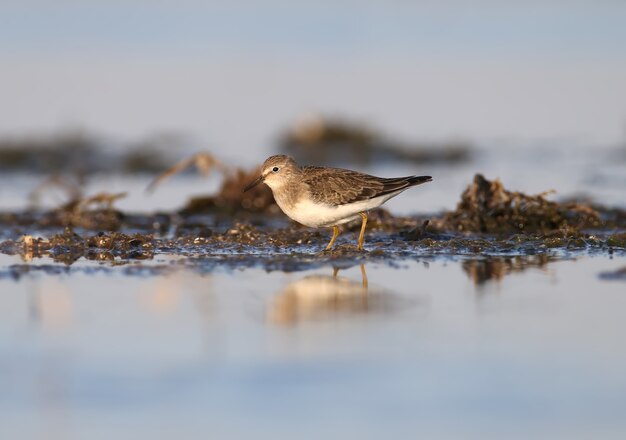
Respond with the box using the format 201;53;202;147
267;265;410;325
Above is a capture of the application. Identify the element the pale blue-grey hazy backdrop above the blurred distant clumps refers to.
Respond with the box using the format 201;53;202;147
0;0;626;153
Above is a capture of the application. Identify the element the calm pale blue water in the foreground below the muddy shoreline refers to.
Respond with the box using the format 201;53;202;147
0;251;626;438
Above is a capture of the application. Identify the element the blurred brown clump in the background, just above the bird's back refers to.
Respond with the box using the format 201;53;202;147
280;116;471;165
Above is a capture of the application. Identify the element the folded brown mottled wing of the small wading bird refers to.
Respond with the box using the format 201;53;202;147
303;167;431;205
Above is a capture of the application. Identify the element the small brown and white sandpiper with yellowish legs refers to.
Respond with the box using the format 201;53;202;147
244;155;432;251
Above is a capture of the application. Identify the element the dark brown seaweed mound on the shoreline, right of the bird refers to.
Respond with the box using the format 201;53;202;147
434;174;604;233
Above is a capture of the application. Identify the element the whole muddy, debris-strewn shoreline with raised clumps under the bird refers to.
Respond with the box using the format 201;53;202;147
0;175;626;276
